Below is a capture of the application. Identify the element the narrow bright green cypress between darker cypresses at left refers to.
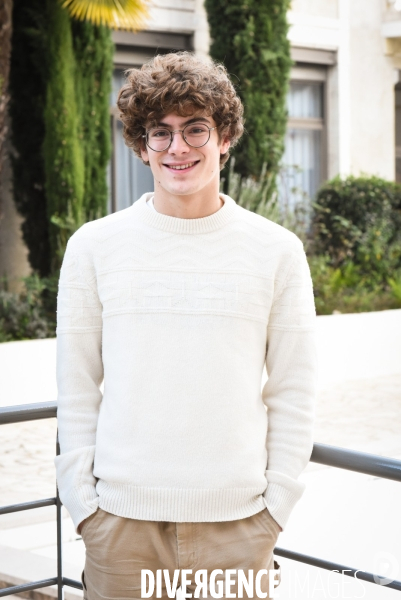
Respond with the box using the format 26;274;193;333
43;0;84;270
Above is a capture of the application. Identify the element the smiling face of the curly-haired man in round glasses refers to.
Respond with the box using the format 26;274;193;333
141;112;230;196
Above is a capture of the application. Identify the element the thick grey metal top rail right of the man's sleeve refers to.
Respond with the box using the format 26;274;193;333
310;444;401;481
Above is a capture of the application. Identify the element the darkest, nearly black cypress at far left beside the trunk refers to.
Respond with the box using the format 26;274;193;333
9;0;50;277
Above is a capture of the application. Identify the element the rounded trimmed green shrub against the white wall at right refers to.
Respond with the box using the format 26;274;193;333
313;177;401;283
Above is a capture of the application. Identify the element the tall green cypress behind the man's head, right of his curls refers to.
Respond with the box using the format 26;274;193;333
205;0;291;189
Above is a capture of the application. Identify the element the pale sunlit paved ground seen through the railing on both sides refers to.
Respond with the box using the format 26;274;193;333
0;375;401;600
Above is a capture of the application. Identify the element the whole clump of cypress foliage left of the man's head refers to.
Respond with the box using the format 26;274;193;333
11;0;113;276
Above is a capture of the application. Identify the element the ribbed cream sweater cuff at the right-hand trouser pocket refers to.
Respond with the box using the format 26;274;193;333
263;471;306;530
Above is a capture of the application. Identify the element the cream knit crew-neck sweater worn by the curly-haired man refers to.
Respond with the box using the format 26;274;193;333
56;194;317;528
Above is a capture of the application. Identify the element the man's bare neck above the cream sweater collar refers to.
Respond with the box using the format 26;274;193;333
153;180;224;219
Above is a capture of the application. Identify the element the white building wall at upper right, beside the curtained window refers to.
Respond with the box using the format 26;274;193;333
288;0;401;180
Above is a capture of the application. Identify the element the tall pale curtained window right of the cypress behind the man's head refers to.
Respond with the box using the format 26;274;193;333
279;77;325;209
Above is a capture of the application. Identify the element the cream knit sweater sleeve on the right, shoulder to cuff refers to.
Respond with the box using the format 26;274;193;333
262;242;317;529
